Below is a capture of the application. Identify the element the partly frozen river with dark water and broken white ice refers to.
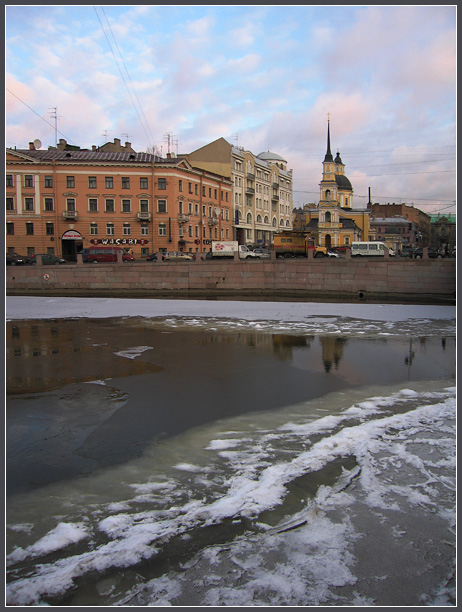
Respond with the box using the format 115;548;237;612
6;297;456;606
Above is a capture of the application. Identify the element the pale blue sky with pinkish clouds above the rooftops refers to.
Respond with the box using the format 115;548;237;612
5;5;457;214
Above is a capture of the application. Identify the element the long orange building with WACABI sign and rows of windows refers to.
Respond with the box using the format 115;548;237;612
6;143;233;261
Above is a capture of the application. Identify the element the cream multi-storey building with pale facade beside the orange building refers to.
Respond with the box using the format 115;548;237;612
181;138;293;246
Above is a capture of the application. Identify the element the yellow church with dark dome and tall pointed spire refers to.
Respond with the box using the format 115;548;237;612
294;119;370;248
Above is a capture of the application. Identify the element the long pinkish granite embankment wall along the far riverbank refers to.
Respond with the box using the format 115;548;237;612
6;258;456;304
